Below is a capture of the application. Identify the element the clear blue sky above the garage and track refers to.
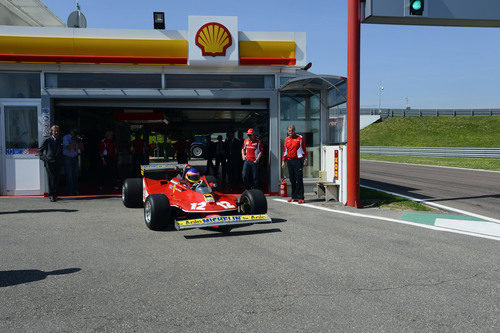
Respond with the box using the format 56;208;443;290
42;0;500;109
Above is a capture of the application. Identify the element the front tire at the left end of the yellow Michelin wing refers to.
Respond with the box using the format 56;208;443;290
144;194;175;230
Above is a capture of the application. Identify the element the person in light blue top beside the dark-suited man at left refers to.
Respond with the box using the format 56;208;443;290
63;128;83;195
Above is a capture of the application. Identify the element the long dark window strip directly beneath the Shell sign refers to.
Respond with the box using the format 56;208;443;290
165;74;274;89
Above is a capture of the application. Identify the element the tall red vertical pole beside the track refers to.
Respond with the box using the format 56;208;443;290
346;0;362;208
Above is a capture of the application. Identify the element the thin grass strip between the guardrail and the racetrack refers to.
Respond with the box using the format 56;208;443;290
361;154;500;171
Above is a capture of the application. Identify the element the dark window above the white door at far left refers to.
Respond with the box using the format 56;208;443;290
0;72;41;98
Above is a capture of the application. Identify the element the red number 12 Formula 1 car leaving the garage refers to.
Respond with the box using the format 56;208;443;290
122;163;271;231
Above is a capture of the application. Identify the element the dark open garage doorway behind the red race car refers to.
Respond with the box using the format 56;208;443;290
54;99;269;194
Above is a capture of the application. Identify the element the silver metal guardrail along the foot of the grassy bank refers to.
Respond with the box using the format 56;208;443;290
360;146;500;158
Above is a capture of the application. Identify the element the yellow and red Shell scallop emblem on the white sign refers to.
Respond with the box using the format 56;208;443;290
194;22;233;57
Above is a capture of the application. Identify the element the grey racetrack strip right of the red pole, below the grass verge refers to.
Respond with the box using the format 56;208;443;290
360;160;500;219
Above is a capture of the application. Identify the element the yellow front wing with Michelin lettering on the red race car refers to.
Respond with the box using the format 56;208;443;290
175;214;271;230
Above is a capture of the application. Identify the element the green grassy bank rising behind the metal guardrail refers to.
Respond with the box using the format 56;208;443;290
360;116;500;148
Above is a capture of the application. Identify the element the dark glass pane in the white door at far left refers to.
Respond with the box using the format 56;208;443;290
4;106;38;153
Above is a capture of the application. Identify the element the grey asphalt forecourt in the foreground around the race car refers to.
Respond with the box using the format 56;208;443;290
0;198;500;332
